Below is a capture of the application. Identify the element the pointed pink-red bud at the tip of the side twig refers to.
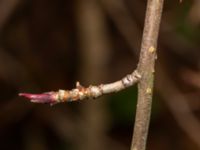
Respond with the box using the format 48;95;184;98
19;92;57;104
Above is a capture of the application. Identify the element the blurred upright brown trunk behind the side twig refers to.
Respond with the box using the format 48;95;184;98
75;0;111;150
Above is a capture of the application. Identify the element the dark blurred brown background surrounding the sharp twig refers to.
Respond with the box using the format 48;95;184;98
0;0;200;150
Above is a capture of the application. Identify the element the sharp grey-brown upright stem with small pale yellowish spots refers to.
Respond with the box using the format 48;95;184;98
131;0;164;150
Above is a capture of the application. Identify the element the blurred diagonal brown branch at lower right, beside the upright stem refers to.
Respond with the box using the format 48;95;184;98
156;66;200;148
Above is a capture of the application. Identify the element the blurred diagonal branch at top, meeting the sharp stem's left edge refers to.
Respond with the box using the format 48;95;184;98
99;0;141;55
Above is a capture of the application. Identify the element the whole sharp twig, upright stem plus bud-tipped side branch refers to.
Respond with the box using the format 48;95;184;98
20;0;164;150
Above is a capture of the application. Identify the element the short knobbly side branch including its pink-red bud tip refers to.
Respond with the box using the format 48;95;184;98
19;70;141;104
